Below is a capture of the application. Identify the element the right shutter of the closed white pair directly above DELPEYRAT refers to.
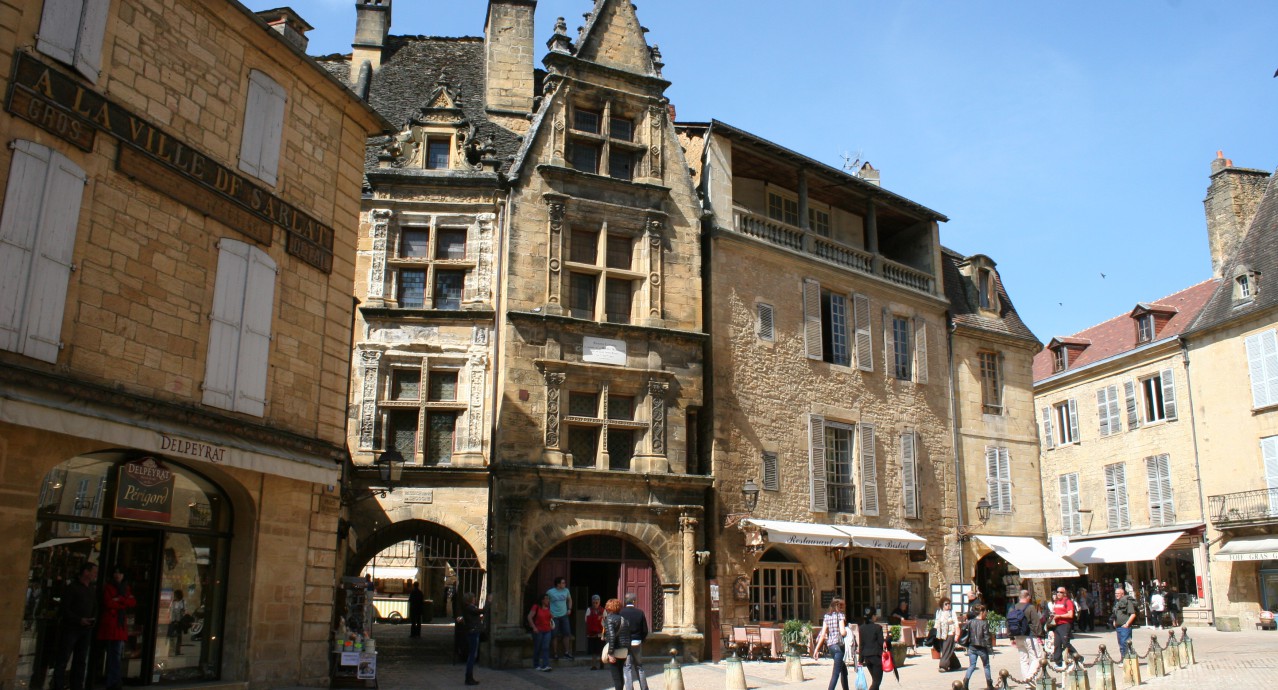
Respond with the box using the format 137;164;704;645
235;247;275;417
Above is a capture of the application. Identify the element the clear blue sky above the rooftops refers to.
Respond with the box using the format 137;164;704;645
245;0;1278;342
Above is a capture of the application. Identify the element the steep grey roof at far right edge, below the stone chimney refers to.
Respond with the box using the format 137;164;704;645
1189;171;1278;332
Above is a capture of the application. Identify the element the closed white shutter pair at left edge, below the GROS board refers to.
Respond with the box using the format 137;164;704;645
0;139;86;362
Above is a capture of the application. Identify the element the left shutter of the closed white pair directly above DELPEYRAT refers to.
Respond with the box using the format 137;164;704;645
203;238;249;410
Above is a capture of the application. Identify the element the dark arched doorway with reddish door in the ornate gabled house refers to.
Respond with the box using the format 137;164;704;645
521;534;663;649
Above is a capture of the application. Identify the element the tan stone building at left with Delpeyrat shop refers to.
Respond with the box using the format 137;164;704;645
0;0;385;687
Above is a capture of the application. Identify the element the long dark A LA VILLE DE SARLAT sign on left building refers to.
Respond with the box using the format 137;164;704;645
5;52;334;272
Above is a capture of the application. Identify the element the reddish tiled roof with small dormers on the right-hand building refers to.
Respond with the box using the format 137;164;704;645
1034;279;1220;383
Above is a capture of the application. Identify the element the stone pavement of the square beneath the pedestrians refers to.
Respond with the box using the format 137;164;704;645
334;625;1278;690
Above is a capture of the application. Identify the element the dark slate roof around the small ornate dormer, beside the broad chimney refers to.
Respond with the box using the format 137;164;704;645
316;36;529;181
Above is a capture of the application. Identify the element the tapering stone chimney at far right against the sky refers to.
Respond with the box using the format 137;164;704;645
1203;151;1269;277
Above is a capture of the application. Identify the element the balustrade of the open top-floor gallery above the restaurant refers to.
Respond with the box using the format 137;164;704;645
732;207;935;295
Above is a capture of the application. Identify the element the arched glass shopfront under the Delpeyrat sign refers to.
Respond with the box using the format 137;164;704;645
18;452;231;687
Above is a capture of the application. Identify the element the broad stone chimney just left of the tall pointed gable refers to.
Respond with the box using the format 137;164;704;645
483;0;537;114
